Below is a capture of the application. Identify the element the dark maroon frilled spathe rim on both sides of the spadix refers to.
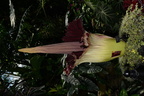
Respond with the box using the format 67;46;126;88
62;19;85;75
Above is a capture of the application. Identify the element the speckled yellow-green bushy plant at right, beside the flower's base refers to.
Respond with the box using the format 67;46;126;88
119;6;144;67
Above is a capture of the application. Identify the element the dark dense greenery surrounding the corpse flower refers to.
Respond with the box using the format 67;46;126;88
0;0;143;96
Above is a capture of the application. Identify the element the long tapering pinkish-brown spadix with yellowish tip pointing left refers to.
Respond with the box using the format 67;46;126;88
18;42;83;54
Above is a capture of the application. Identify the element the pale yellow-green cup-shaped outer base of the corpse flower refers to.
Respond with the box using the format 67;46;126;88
75;34;125;66
